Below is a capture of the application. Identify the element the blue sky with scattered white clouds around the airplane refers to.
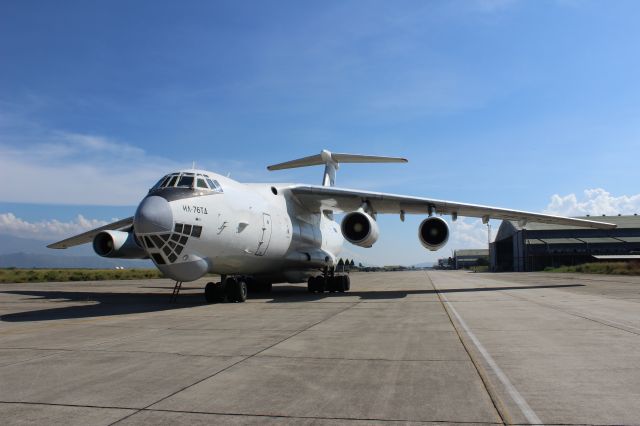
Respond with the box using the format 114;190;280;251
0;0;640;264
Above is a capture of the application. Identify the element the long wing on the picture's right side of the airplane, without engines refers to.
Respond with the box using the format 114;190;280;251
290;185;616;229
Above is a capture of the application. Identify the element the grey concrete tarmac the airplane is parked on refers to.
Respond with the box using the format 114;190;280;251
0;271;640;425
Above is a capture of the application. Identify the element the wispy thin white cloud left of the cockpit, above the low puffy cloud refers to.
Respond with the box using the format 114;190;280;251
0;128;187;205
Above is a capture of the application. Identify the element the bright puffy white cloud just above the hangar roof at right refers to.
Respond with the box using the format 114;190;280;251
545;188;640;216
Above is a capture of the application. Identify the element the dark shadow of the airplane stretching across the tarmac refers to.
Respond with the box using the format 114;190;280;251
0;284;584;322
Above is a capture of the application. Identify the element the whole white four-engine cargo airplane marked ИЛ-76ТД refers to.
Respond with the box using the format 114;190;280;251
47;150;616;303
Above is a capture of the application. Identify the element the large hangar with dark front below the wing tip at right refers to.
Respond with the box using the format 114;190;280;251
490;215;640;272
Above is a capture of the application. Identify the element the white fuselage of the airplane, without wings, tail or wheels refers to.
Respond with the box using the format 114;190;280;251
138;172;343;282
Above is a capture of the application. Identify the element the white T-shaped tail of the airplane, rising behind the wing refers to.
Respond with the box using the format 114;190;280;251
267;149;407;186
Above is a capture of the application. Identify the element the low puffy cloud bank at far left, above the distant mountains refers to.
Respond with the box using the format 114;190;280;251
0;213;109;241
